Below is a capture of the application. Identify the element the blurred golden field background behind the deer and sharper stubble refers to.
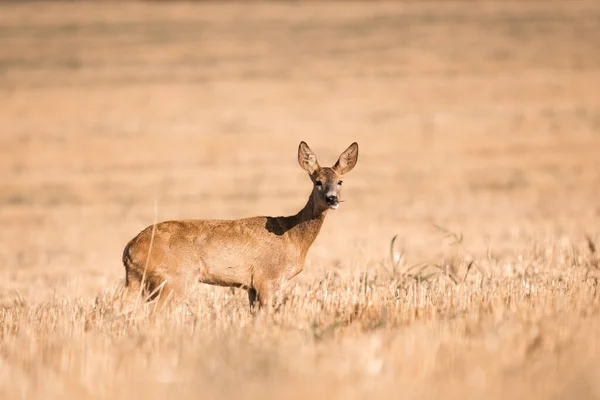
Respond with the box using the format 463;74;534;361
0;1;600;300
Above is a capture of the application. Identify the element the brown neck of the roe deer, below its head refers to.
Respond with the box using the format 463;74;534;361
289;192;328;253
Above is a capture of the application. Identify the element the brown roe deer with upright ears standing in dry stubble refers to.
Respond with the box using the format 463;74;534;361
123;142;358;309
